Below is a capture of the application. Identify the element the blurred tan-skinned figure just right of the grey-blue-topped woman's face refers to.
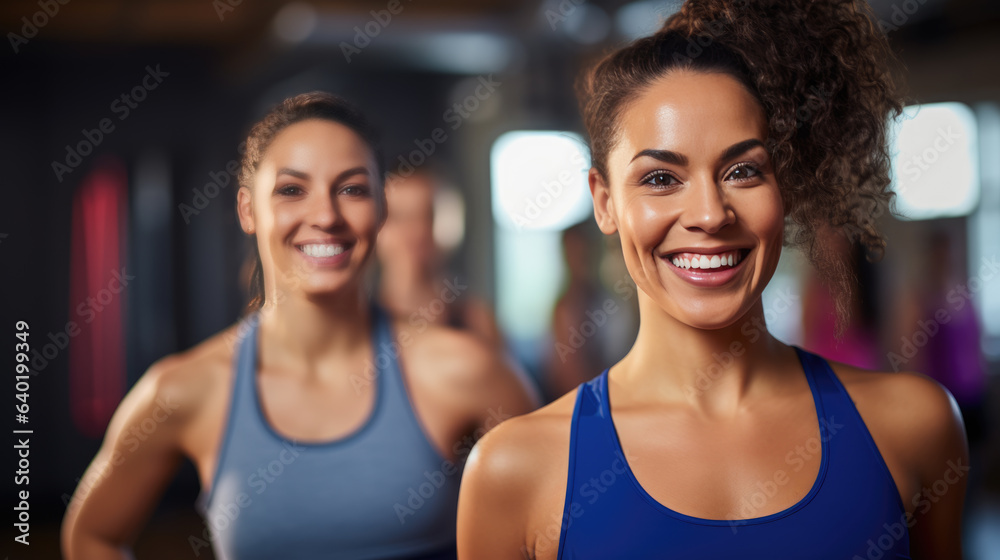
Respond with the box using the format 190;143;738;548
376;168;503;349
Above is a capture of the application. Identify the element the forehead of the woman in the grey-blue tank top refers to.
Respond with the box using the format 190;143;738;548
261;119;374;167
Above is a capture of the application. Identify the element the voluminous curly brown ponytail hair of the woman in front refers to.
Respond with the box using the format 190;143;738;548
578;0;903;328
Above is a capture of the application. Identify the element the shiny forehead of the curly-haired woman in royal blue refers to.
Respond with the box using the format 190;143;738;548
619;70;767;158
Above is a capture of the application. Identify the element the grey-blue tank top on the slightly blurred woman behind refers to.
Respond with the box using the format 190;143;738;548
199;308;461;560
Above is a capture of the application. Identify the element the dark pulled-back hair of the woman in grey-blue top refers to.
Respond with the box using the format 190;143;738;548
239;91;386;312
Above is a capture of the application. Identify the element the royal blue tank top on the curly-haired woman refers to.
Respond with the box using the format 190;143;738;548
558;348;910;560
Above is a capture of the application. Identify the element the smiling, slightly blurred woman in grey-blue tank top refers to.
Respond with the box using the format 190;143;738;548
62;92;533;560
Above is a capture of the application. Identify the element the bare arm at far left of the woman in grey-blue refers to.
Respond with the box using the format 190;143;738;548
62;365;189;560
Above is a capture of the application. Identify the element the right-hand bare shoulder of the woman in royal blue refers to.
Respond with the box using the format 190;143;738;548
830;362;965;474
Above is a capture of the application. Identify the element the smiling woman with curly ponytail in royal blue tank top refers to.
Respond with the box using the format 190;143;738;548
458;0;968;560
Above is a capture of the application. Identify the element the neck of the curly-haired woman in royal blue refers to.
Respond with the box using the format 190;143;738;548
611;291;797;414
